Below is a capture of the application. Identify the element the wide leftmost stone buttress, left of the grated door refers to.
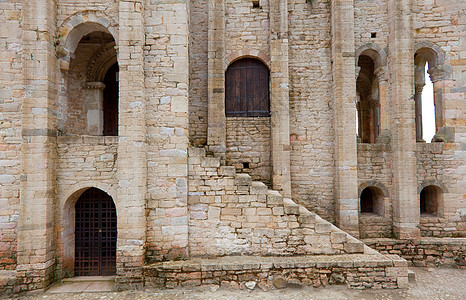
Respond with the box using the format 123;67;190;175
16;0;58;290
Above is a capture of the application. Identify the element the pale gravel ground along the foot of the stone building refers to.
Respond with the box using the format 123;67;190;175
12;268;466;300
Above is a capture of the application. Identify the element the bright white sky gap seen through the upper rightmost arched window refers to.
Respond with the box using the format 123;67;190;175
422;63;436;143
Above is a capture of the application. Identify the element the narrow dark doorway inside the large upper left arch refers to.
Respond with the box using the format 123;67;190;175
103;64;119;135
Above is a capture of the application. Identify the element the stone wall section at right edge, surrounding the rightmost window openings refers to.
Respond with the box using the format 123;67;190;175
413;0;466;236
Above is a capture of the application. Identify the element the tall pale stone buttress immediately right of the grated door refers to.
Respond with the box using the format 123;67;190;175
115;0;147;286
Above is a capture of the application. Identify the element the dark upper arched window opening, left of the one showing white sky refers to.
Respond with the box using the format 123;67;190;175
356;51;380;143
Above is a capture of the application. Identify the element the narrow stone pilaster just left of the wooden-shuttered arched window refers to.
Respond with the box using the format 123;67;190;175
207;0;226;156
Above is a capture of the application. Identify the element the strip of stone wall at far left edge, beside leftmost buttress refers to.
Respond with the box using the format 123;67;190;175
0;0;24;272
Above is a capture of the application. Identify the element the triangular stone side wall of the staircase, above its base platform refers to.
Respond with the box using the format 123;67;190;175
187;148;364;257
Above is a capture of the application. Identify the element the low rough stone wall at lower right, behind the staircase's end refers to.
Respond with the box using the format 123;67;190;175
362;238;466;267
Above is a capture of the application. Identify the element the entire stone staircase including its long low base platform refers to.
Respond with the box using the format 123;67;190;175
143;148;408;288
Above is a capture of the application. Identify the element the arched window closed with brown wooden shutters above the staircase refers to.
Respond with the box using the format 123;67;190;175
225;58;270;117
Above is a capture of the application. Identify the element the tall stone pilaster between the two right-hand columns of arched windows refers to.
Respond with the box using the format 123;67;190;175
388;0;420;239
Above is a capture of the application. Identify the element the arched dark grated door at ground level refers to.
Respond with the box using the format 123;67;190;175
74;188;117;276
